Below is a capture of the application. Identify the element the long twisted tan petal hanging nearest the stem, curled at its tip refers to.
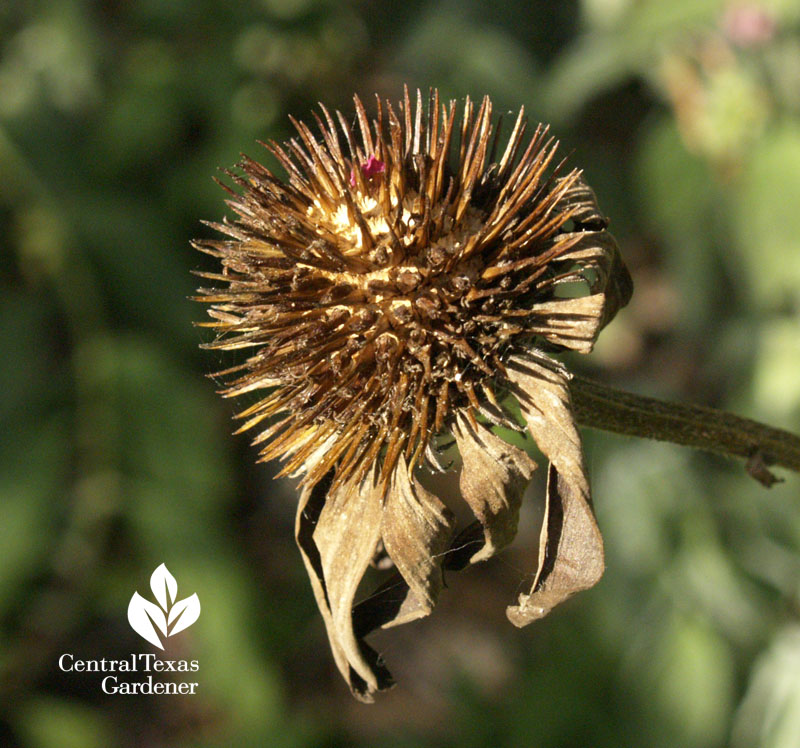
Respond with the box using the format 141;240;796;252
506;355;604;626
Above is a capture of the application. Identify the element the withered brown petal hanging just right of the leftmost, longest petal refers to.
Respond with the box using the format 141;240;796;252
381;456;455;627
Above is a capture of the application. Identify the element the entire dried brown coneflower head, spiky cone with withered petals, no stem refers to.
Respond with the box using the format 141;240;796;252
196;90;632;700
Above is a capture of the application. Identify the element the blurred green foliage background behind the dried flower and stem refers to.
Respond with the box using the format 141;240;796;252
0;0;800;748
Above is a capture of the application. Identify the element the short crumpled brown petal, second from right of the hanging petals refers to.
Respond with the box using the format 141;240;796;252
453;414;536;564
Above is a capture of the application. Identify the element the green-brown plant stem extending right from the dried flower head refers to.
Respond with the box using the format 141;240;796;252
570;376;800;485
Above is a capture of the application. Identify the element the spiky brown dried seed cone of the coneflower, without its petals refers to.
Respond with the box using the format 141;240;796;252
197;91;632;484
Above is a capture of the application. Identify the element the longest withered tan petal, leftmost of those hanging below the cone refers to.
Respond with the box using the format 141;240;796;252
295;471;392;702
